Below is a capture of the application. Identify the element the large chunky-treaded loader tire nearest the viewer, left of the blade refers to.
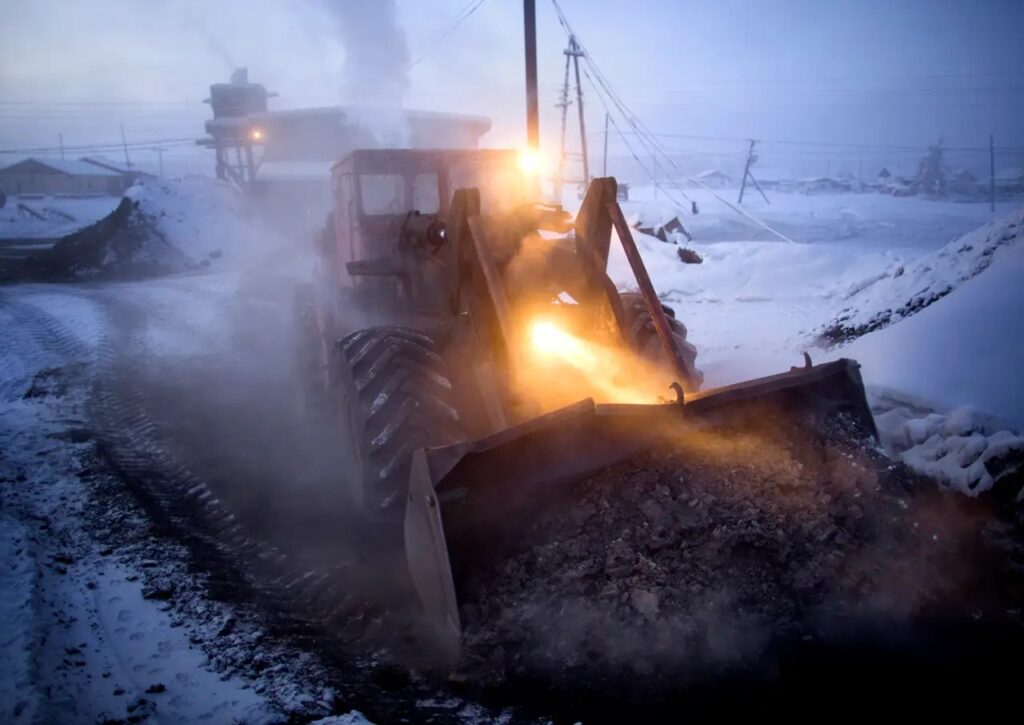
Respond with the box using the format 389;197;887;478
336;327;463;514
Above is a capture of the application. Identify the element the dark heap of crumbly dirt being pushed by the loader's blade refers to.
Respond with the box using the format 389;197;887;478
462;419;1020;694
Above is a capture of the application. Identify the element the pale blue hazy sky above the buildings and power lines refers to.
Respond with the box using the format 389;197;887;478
0;0;1024;177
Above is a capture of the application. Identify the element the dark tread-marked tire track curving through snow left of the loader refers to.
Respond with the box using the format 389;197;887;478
6;288;490;723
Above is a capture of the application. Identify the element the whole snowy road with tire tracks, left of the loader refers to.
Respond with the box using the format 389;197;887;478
0;274;499;723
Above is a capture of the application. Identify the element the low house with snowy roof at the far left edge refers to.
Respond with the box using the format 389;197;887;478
0;158;125;196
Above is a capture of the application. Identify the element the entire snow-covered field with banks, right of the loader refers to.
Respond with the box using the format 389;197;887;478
609;188;1024;493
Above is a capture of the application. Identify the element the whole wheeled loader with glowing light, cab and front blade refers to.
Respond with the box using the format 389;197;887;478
295;150;876;658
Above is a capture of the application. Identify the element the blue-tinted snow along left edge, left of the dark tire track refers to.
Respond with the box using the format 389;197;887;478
0;286;294;723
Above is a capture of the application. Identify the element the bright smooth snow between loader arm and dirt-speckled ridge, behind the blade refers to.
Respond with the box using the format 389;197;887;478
608;231;898;386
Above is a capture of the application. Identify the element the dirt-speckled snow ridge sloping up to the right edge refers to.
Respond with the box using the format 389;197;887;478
822;208;1024;342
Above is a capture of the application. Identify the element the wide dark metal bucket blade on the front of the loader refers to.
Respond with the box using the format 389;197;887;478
404;359;876;662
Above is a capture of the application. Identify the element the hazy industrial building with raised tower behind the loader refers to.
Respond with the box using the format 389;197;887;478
199;69;490;233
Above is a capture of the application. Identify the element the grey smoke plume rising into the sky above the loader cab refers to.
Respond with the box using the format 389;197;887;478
326;0;410;146
